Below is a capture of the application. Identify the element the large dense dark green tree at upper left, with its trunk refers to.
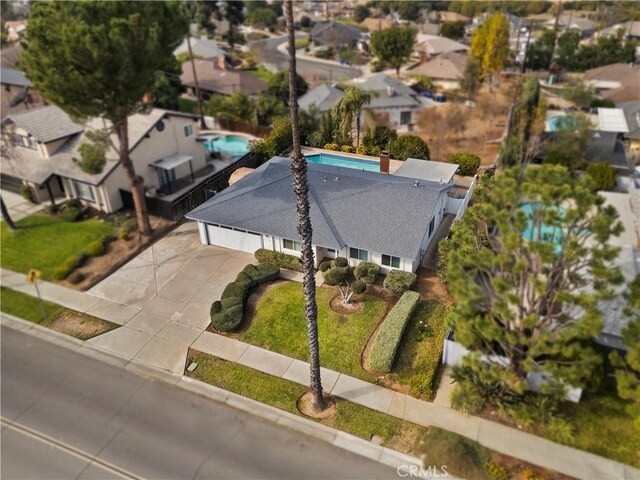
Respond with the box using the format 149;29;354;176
21;1;188;235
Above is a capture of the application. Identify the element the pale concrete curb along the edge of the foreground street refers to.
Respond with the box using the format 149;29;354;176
5;313;428;478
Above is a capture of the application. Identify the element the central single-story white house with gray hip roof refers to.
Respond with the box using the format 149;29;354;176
186;157;453;273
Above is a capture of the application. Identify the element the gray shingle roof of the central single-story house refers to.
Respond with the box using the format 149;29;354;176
186;157;451;258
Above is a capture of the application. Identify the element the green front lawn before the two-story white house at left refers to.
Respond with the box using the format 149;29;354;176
0;215;113;280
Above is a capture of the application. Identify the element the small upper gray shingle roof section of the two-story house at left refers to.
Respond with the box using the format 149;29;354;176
7;105;84;143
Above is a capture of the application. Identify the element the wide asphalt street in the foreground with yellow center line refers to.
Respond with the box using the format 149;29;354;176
1;327;397;479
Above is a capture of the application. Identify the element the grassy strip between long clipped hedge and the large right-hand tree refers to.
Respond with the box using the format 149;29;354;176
391;300;447;400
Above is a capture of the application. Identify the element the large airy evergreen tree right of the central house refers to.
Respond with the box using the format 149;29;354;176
447;165;623;395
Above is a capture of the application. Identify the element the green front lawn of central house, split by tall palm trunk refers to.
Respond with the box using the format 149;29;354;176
240;282;387;381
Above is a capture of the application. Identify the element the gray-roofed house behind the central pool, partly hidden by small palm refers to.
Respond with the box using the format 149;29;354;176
298;73;422;130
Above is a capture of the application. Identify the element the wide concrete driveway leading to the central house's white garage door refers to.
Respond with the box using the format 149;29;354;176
87;222;256;373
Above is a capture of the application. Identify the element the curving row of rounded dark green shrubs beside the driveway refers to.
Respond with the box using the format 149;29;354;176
210;264;280;332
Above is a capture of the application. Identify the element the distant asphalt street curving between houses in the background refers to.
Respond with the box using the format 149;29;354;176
250;36;362;84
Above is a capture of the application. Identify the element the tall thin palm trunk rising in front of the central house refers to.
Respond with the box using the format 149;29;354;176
285;0;325;410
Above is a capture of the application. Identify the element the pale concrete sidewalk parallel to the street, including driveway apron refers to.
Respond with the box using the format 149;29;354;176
2;270;640;479
